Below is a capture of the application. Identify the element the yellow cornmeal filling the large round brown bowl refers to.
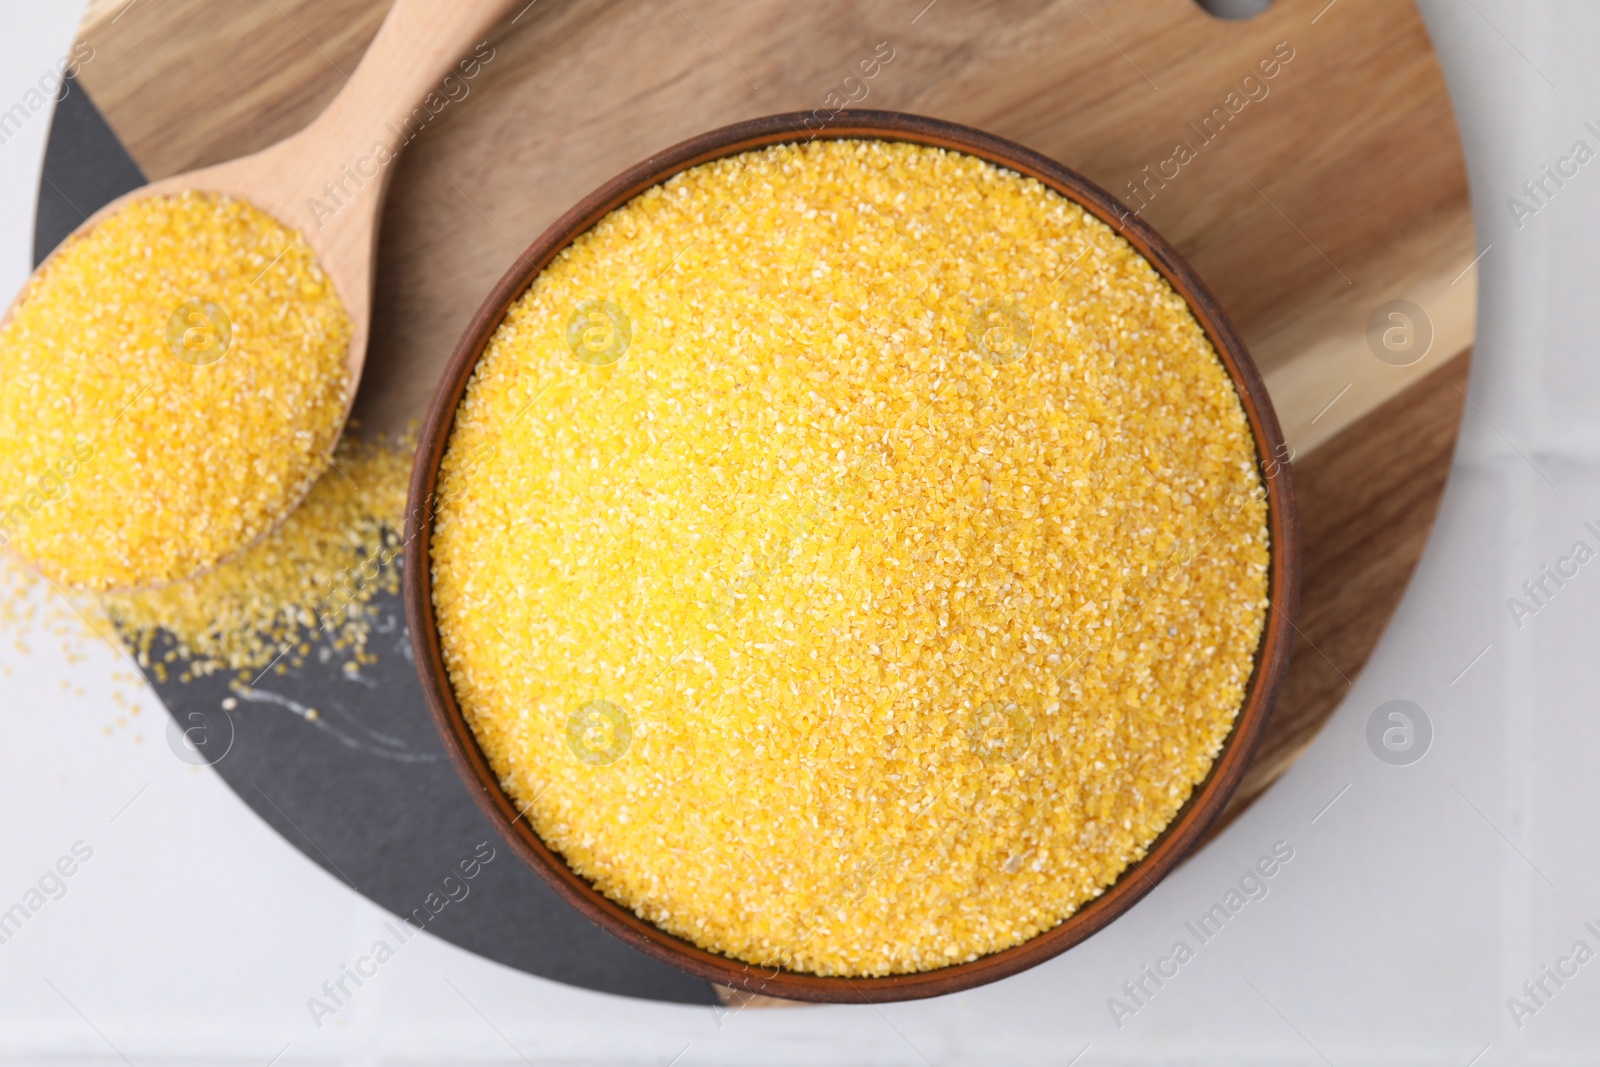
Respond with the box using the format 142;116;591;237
432;141;1269;976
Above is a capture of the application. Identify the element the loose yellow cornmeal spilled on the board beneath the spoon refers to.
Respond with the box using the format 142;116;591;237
99;437;411;673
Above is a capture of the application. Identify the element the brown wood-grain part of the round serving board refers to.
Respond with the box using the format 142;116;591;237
65;0;1477;979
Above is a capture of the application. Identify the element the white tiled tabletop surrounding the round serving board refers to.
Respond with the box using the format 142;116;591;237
0;0;1600;1067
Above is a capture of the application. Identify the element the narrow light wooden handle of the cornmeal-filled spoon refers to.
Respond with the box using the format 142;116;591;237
293;0;526;183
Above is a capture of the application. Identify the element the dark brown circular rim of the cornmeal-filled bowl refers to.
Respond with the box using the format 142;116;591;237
402;109;1299;1003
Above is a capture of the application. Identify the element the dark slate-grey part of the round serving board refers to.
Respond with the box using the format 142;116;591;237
34;82;717;1005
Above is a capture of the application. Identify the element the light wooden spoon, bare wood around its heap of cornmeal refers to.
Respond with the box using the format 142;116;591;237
6;0;525;588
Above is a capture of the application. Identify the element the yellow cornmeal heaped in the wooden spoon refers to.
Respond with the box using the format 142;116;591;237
0;192;350;590
